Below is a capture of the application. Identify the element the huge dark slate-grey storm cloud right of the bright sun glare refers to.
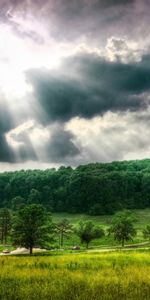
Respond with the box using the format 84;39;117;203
27;54;150;123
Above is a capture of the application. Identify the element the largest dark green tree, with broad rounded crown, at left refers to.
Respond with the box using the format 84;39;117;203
12;204;49;254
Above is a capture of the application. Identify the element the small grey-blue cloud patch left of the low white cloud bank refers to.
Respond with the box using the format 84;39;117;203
46;125;80;162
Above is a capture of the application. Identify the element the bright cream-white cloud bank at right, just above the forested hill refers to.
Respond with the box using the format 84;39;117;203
66;110;150;163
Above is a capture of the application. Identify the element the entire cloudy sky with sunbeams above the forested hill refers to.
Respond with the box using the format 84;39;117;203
0;0;150;172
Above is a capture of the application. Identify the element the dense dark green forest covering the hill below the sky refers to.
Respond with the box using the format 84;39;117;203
0;159;150;215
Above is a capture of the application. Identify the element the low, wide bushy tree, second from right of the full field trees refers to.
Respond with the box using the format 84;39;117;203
76;221;104;249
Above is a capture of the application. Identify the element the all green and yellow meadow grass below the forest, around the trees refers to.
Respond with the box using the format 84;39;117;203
0;209;150;300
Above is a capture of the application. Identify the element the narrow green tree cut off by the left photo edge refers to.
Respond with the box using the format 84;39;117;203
0;208;11;244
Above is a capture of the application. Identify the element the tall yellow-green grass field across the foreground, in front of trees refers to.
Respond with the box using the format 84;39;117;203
0;251;150;300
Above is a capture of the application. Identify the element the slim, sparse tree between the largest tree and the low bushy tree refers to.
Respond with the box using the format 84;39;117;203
55;219;72;247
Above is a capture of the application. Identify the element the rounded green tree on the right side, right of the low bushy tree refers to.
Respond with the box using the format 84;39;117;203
109;211;136;247
